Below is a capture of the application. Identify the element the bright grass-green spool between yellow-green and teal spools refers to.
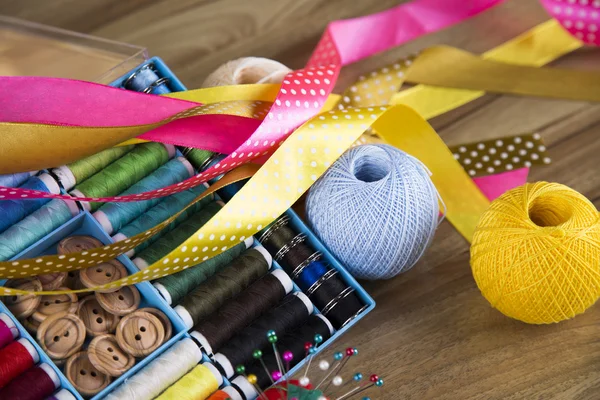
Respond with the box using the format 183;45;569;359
71;142;175;211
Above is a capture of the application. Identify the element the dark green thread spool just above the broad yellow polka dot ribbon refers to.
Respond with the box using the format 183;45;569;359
133;202;223;269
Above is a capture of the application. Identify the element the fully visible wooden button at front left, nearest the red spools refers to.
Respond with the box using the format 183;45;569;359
37;312;85;360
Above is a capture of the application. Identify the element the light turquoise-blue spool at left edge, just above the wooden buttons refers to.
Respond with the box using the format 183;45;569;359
0;199;79;261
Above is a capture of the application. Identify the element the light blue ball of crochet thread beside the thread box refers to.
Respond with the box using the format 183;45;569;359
306;145;439;279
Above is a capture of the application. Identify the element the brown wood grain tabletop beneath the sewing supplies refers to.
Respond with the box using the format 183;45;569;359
0;0;600;400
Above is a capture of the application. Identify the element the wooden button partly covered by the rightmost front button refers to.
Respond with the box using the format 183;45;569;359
88;334;135;378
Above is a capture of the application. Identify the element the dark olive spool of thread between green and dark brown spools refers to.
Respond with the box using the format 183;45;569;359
175;246;274;329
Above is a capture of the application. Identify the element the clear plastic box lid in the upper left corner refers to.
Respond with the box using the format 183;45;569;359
0;16;148;83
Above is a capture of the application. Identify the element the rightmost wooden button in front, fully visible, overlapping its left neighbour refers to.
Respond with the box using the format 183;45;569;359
117;310;165;357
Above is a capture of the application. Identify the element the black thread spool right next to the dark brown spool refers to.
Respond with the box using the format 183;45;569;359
215;292;313;378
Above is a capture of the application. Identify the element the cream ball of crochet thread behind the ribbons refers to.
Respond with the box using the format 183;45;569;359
202;57;291;87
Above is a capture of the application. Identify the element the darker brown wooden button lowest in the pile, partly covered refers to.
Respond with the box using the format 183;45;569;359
65;351;110;397
